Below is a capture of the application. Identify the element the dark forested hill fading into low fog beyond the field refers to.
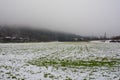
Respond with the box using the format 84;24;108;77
0;26;82;42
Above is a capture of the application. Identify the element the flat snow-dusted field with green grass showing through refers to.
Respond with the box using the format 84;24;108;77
0;42;120;80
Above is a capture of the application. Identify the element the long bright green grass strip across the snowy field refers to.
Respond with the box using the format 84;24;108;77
28;58;120;67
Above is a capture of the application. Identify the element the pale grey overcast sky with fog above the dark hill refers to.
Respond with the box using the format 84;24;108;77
0;0;120;36
